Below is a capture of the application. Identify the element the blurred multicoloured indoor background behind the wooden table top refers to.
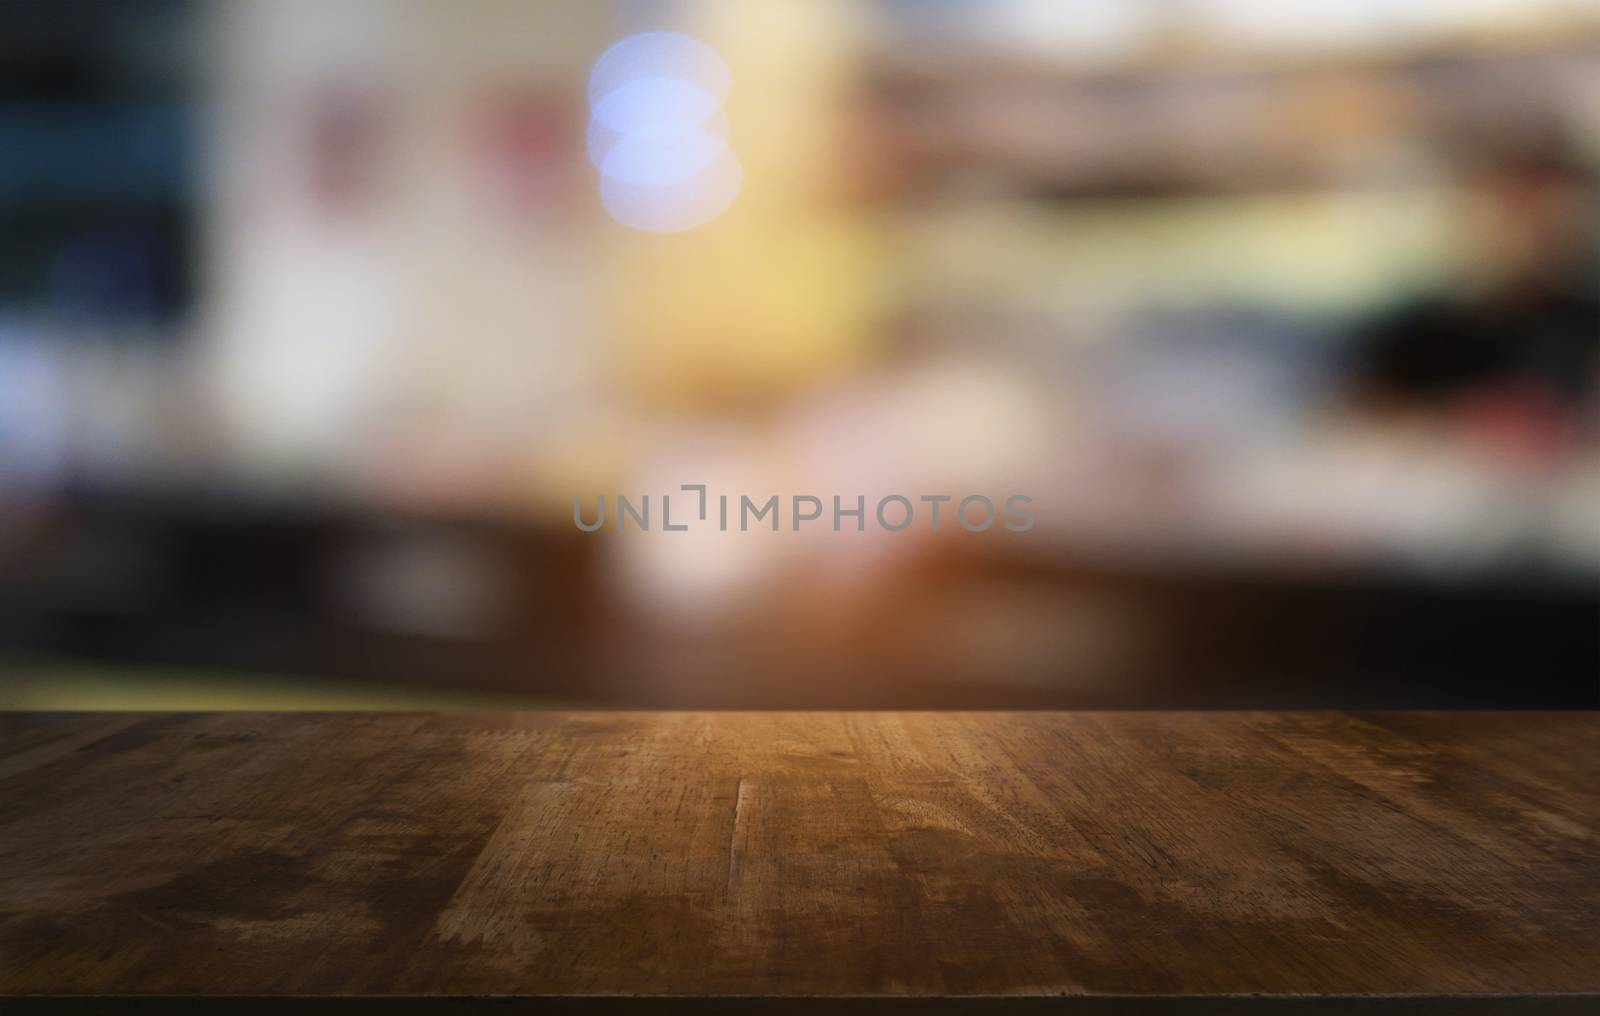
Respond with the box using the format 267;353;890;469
0;0;1600;709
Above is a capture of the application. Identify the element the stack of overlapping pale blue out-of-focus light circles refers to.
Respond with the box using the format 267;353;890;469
589;32;744;232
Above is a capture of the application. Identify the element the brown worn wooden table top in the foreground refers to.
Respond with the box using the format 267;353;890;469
0;712;1600;1011
